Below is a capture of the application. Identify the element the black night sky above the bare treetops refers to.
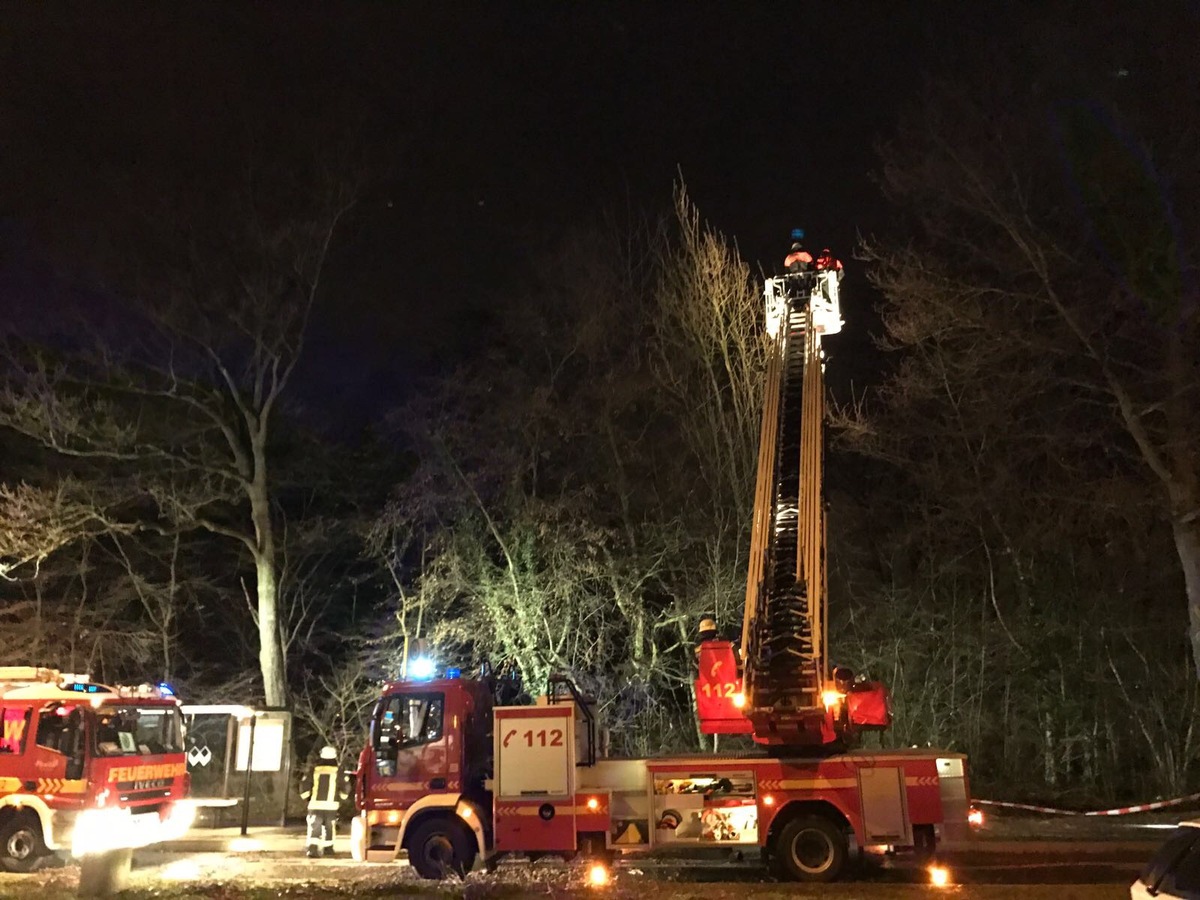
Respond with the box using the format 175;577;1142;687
0;2;1022;415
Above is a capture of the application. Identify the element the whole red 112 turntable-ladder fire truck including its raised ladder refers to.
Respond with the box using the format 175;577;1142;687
350;244;968;881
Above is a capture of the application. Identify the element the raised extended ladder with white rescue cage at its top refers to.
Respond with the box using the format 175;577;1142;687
742;272;841;744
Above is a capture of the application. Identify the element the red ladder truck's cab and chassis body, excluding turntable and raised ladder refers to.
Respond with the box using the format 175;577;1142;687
350;672;968;881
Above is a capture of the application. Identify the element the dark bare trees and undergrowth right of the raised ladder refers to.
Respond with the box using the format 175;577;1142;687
830;15;1200;798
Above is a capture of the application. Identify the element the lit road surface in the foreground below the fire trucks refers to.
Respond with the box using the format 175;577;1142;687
0;842;1154;900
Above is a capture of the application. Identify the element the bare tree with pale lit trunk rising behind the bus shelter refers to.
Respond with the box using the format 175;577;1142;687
0;176;354;706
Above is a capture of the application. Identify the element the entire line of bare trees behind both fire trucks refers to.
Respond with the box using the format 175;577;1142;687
0;7;1200;803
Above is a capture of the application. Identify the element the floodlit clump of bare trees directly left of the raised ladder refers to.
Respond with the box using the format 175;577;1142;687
379;190;764;752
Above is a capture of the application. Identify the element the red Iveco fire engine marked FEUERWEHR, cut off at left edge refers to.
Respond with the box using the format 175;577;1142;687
0;666;193;872
